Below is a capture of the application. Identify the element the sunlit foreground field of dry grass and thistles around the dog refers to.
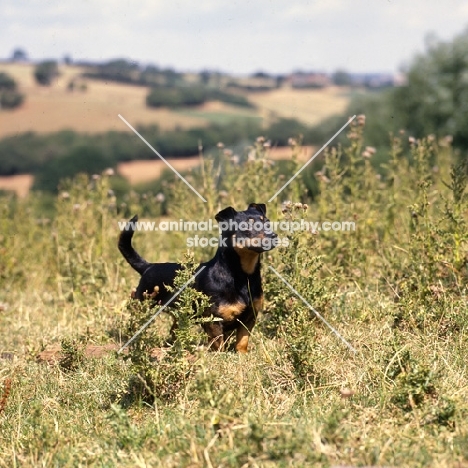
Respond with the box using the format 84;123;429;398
0;122;468;468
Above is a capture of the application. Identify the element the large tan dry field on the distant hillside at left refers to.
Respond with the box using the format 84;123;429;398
0;64;206;138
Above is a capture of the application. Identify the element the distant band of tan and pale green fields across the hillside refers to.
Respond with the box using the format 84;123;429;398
0;63;349;138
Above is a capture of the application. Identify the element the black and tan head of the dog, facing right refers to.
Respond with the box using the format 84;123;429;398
215;203;278;253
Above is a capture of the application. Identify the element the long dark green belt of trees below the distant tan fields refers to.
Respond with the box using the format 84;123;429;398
0;120;303;180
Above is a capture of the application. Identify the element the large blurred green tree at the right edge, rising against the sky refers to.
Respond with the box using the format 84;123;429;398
312;27;468;150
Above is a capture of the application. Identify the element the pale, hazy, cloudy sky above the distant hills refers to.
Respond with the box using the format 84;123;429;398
0;0;468;74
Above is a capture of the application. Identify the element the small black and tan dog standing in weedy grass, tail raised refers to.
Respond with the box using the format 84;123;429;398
119;203;278;353
